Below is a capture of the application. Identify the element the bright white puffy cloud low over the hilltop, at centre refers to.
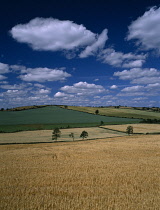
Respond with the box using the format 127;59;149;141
60;82;105;95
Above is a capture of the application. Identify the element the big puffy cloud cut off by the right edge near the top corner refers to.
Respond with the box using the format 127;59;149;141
127;7;160;51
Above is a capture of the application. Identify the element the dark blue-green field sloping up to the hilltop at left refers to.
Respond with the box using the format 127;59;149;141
0;106;139;132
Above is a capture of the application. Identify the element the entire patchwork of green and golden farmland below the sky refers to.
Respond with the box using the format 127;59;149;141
0;106;160;210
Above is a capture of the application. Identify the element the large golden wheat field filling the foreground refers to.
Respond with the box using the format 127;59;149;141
0;135;160;210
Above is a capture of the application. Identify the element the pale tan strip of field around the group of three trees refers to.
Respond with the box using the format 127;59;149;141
0;127;125;144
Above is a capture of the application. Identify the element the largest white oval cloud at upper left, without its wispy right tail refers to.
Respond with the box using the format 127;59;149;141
10;18;96;51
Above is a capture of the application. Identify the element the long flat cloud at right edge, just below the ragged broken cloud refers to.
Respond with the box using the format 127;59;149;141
114;68;160;84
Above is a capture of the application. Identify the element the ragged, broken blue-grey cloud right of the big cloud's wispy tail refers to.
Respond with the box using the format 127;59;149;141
98;48;147;68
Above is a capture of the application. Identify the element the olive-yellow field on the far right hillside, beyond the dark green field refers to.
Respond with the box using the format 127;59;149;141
64;106;160;119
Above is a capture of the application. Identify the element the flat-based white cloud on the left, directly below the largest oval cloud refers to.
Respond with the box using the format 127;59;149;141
19;68;71;82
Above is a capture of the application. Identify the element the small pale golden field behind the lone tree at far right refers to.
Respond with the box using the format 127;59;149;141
101;123;160;133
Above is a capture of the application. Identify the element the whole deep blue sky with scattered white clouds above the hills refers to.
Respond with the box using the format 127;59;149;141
0;0;160;108
